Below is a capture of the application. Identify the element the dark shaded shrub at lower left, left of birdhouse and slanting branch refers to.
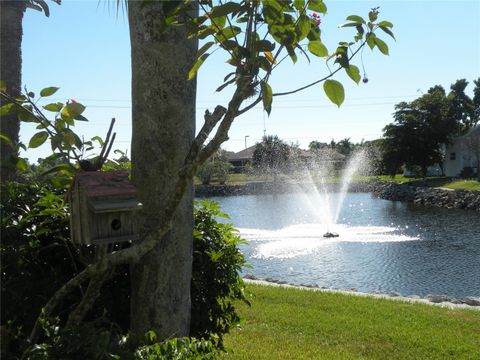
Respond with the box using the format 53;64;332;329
0;182;82;342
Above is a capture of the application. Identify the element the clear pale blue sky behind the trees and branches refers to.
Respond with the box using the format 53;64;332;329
20;0;480;161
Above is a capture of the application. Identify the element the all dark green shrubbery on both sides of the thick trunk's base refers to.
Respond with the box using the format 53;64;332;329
0;182;246;359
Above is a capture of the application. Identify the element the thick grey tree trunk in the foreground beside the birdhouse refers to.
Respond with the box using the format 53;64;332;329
128;1;198;339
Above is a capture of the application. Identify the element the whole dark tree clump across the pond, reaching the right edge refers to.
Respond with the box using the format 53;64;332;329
383;79;480;176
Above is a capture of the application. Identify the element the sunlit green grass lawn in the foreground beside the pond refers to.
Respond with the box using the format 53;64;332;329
221;284;480;360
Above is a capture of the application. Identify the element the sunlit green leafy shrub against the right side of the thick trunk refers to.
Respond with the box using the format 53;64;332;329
190;200;248;346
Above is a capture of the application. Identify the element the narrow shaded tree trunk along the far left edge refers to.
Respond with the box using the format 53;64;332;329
0;0;25;181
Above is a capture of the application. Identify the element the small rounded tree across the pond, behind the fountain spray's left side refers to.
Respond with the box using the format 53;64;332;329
253;135;290;182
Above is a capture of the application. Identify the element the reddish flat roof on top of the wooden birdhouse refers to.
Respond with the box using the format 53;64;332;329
71;171;136;198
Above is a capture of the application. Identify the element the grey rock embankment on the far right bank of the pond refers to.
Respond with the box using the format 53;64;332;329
371;182;480;211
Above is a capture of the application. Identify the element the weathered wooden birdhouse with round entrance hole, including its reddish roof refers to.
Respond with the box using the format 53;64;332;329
67;171;142;245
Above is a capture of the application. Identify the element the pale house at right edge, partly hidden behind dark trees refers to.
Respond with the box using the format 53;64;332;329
443;125;480;176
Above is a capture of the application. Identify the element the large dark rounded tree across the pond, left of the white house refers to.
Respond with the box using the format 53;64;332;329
383;86;459;176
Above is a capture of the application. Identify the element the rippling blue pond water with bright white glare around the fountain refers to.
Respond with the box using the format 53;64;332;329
211;193;480;298
